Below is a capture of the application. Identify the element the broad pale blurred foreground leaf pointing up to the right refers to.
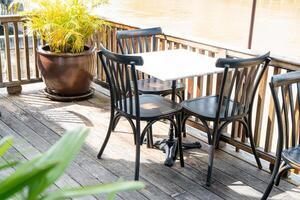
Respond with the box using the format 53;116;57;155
28;128;89;199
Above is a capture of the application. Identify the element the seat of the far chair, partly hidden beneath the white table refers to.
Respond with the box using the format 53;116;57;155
137;78;184;95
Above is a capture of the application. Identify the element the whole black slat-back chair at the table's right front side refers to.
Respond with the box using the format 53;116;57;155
182;53;270;186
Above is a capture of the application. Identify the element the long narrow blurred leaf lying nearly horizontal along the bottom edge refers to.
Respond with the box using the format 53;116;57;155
42;181;145;200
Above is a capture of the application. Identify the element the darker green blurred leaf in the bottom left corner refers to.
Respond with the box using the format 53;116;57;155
0;157;58;199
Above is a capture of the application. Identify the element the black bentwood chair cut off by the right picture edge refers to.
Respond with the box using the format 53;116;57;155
262;71;300;199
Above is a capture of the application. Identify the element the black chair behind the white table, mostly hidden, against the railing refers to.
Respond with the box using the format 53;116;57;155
113;27;185;144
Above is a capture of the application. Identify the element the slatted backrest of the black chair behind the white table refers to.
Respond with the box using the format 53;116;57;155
117;27;165;54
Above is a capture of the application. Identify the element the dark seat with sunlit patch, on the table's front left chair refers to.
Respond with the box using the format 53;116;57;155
122;94;182;121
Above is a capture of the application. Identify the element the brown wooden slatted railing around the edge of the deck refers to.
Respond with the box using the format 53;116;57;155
0;16;300;169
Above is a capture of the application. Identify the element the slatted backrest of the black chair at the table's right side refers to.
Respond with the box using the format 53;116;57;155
216;53;270;117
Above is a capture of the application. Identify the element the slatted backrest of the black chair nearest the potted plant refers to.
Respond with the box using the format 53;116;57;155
98;45;143;115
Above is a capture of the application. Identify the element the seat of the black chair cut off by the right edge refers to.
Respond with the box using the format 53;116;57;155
282;145;300;169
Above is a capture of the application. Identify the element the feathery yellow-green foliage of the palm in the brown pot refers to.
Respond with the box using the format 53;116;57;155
25;0;107;53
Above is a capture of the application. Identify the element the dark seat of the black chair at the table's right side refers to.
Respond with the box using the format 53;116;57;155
181;96;243;121
